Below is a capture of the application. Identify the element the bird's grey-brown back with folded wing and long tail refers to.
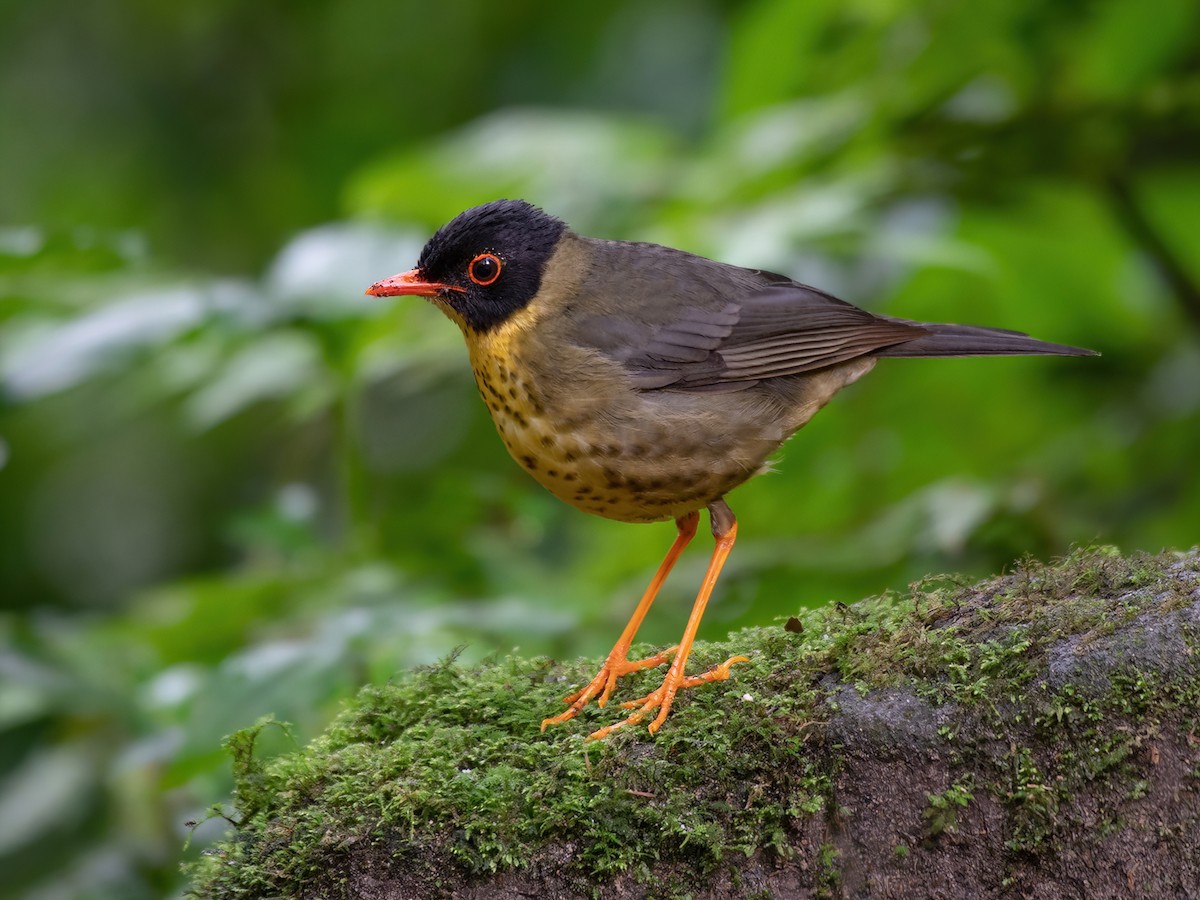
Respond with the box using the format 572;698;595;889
558;239;1091;391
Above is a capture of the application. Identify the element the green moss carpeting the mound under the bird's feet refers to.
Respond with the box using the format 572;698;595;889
192;548;1200;896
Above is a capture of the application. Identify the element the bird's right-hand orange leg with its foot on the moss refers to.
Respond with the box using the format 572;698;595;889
588;500;750;740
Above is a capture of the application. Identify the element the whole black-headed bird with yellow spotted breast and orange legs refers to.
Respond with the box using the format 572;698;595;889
366;199;1098;739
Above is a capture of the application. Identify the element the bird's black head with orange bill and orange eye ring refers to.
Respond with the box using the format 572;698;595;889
367;200;566;331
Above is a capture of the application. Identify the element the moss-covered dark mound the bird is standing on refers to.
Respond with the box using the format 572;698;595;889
193;548;1200;898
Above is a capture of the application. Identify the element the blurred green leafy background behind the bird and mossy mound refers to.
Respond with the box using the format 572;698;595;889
0;0;1200;898
